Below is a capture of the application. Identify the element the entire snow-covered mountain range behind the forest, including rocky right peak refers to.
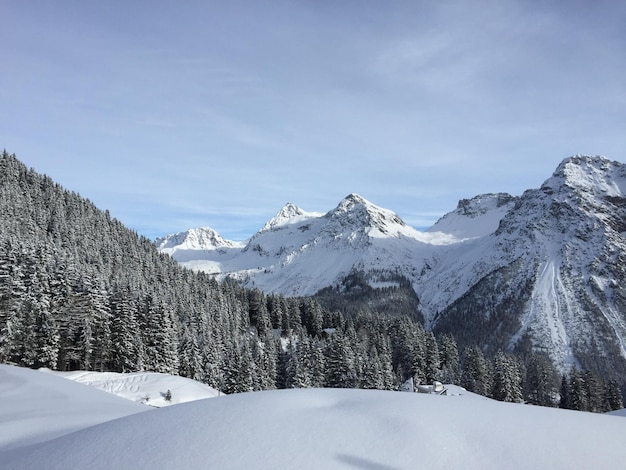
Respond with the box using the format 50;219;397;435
156;156;626;375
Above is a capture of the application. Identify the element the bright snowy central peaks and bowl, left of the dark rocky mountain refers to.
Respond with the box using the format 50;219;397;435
159;190;515;302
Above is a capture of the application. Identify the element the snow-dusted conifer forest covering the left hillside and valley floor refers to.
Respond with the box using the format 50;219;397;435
0;151;622;411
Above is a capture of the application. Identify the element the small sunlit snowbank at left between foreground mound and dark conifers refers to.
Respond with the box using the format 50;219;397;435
40;369;223;408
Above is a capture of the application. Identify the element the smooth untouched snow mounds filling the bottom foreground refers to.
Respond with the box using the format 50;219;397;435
0;366;626;470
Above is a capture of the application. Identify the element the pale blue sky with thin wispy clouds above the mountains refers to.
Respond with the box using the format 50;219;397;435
0;0;626;240
